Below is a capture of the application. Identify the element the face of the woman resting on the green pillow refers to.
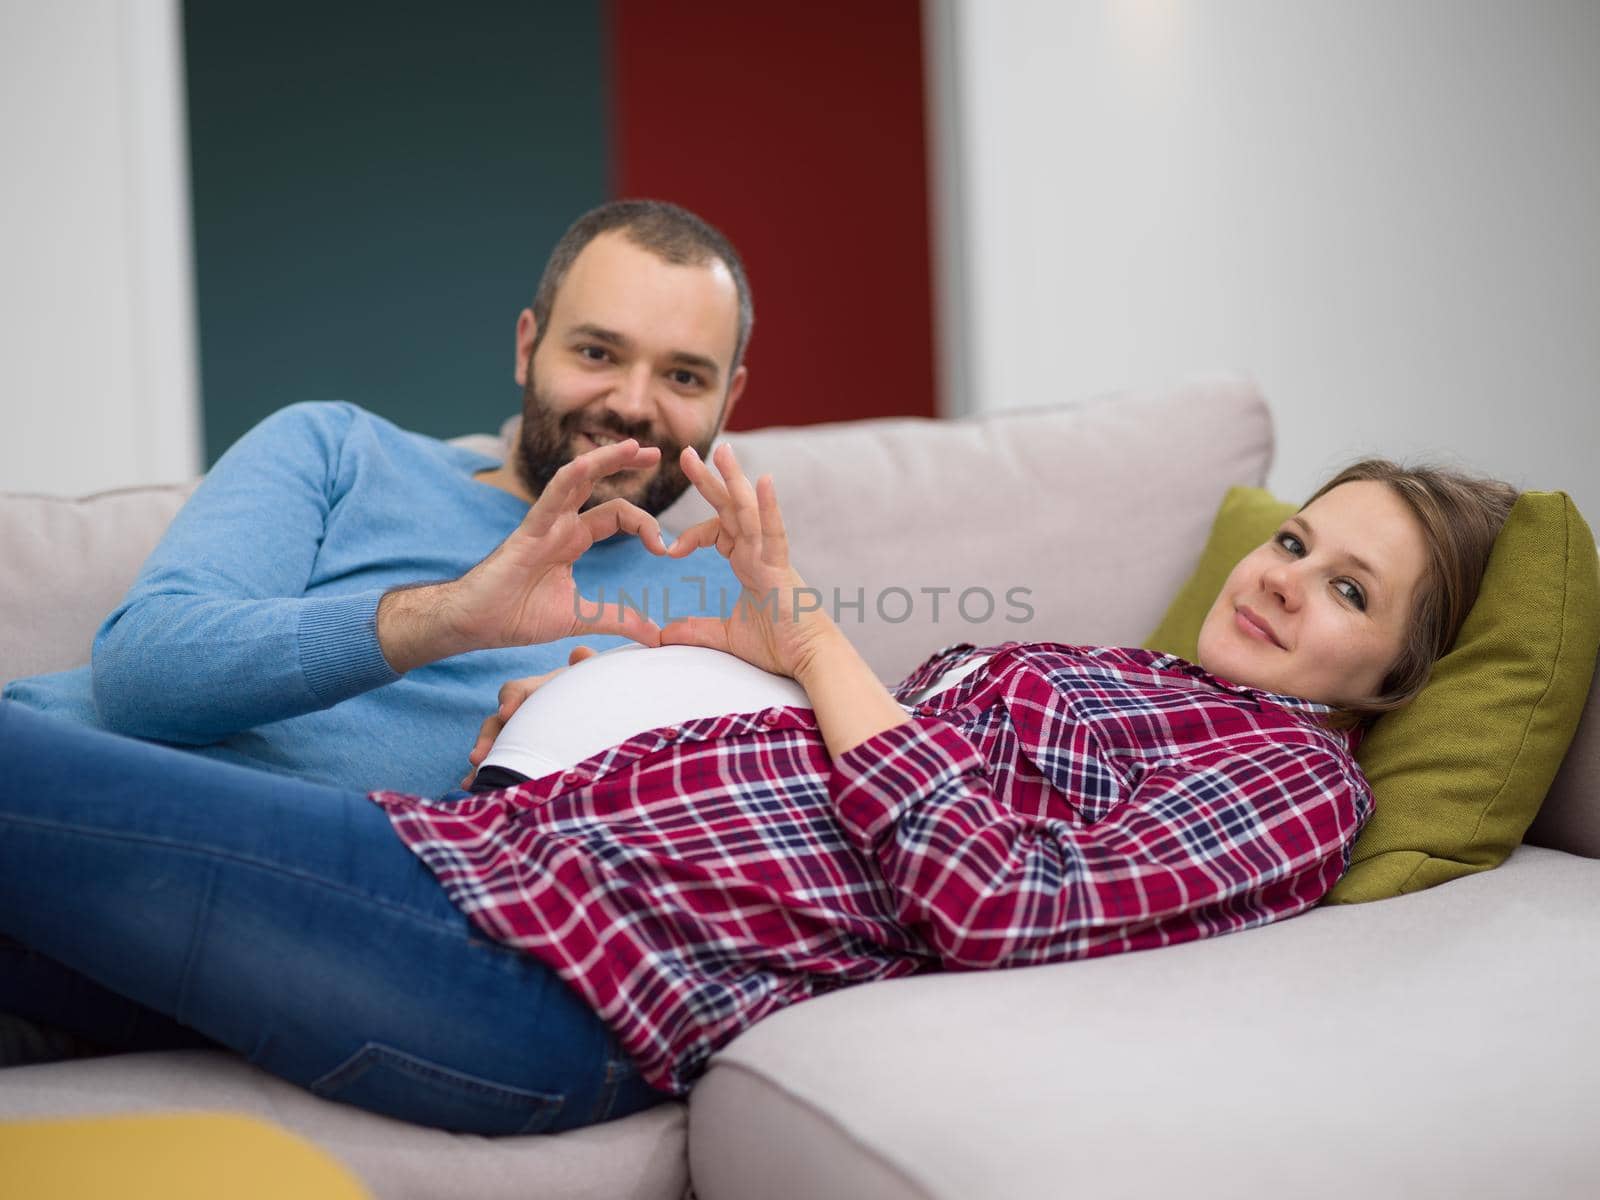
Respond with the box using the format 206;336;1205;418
1200;480;1427;706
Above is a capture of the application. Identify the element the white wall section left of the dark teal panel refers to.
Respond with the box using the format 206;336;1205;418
0;0;200;494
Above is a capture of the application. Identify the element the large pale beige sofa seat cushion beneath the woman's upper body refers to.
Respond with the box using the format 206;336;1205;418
690;846;1600;1200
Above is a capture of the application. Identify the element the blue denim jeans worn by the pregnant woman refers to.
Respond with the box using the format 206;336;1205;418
0;702;666;1134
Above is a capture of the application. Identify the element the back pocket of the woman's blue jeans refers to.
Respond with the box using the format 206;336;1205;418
310;1042;566;1136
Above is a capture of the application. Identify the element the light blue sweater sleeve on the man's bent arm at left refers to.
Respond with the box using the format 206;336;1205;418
93;405;398;744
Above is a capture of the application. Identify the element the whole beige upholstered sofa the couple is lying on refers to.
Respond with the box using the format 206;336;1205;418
0;379;1600;1200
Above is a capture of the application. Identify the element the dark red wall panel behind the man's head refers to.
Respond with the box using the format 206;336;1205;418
608;0;936;429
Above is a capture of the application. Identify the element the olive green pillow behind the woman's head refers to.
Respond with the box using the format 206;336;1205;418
1146;488;1600;904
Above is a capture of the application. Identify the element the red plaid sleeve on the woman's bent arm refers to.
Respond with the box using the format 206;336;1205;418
835;720;1366;970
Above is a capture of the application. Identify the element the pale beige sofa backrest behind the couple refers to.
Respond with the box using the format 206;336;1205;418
0;379;1600;858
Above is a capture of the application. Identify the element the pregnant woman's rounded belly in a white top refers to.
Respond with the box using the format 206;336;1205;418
483;645;811;779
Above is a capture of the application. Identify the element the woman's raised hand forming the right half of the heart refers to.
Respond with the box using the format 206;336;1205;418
661;443;837;677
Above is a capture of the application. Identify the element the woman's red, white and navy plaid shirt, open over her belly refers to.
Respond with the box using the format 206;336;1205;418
373;643;1371;1093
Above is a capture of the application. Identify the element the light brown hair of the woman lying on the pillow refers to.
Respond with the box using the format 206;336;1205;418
1301;458;1517;718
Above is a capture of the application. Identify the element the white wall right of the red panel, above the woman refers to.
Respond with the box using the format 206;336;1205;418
933;0;1600;526
